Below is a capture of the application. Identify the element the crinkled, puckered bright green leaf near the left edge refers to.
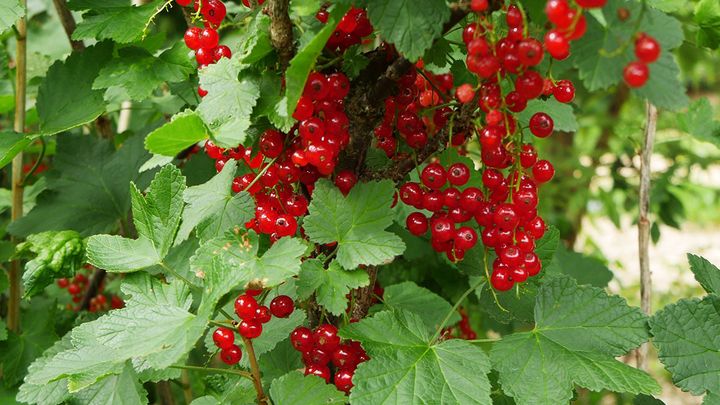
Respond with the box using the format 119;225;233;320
17;231;85;297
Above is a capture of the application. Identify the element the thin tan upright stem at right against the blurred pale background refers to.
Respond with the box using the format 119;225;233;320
637;101;657;370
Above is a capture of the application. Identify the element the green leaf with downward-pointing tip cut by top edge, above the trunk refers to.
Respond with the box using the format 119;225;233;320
367;0;450;62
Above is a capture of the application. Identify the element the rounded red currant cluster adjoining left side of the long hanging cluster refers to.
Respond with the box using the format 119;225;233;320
400;163;484;262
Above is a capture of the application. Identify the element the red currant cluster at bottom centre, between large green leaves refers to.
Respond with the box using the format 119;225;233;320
290;324;369;394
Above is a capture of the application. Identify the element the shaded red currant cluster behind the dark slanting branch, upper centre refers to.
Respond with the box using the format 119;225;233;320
374;67;452;158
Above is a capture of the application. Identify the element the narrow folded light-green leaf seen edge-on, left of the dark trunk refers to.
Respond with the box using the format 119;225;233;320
275;4;350;124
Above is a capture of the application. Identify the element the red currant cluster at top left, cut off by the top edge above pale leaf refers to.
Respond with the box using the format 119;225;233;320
175;0;232;97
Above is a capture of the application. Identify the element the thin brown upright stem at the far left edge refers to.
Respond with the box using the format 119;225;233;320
7;0;27;332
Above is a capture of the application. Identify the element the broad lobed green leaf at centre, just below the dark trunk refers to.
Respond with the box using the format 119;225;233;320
303;180;405;269
